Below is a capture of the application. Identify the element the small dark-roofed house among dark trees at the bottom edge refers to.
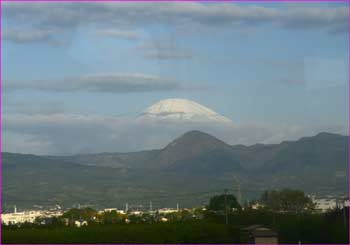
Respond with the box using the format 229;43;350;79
243;225;278;244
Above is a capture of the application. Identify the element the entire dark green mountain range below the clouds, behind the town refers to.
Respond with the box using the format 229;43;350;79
2;131;348;209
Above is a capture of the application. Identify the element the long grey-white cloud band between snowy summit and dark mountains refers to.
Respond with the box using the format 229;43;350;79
3;113;346;154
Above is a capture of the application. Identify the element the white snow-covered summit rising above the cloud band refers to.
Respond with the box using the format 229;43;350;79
139;98;231;123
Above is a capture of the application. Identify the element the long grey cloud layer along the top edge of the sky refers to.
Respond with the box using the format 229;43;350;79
3;2;348;42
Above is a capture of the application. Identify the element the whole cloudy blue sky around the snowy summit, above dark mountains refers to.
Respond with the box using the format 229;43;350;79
1;2;349;155
